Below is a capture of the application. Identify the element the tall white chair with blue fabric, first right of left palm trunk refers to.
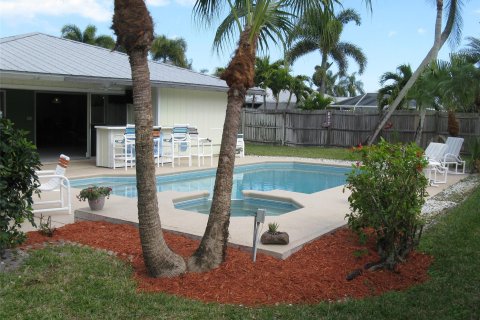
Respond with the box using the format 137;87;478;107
161;124;192;168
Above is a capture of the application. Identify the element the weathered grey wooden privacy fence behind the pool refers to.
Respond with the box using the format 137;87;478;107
242;109;480;151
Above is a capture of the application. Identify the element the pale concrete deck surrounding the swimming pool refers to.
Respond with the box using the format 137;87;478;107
26;156;466;259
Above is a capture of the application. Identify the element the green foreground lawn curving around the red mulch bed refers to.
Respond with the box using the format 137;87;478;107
0;188;480;320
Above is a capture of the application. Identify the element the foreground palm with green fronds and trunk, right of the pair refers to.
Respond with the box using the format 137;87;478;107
188;0;340;271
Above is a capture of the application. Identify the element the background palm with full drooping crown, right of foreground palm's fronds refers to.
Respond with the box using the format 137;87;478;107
287;8;367;94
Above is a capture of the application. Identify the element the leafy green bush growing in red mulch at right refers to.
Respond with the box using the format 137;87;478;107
346;139;428;269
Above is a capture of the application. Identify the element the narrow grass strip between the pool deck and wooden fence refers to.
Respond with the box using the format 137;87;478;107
245;143;359;161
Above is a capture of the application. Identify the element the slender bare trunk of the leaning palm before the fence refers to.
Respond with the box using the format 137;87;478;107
367;0;458;145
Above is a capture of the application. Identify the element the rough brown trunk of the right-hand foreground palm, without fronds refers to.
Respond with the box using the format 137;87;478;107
187;29;258;272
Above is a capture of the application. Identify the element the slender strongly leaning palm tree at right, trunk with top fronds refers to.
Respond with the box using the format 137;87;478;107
367;0;463;145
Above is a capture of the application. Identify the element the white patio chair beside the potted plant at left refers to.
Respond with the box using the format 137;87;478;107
33;154;72;214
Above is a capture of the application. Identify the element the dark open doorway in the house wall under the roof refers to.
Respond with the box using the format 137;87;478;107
35;92;87;162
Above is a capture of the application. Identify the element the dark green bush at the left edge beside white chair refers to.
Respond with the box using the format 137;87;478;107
0;119;40;253
